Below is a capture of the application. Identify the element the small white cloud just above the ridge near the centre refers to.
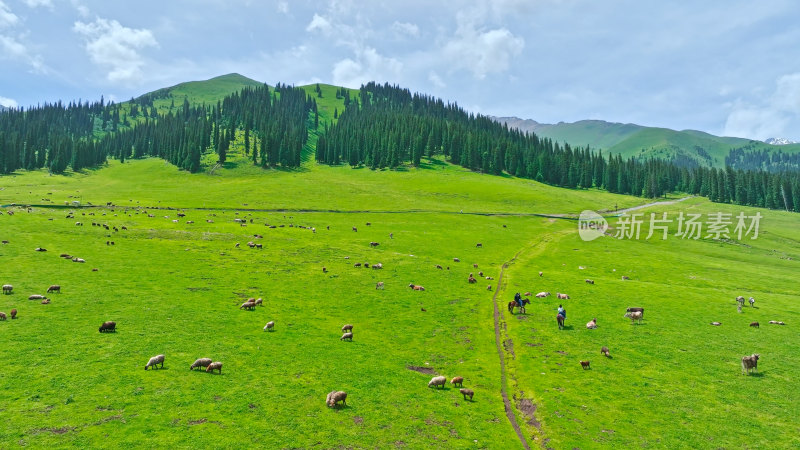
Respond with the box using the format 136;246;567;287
332;47;403;88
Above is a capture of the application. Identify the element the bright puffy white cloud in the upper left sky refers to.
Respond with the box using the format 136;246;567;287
73;18;158;85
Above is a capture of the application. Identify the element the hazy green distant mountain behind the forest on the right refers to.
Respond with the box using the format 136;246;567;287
493;117;800;167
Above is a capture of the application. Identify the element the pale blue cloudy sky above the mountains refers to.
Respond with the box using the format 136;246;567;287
0;0;800;140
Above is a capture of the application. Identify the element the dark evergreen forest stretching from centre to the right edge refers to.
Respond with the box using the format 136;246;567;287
316;83;800;211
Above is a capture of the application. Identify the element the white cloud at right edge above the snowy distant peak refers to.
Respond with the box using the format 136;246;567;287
724;73;800;140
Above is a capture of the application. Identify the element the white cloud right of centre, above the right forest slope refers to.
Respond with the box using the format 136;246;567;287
442;23;525;80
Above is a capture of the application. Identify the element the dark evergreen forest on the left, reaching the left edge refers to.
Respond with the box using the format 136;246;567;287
0;84;316;173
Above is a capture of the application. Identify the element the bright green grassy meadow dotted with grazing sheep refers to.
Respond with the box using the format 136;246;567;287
0;153;800;449
